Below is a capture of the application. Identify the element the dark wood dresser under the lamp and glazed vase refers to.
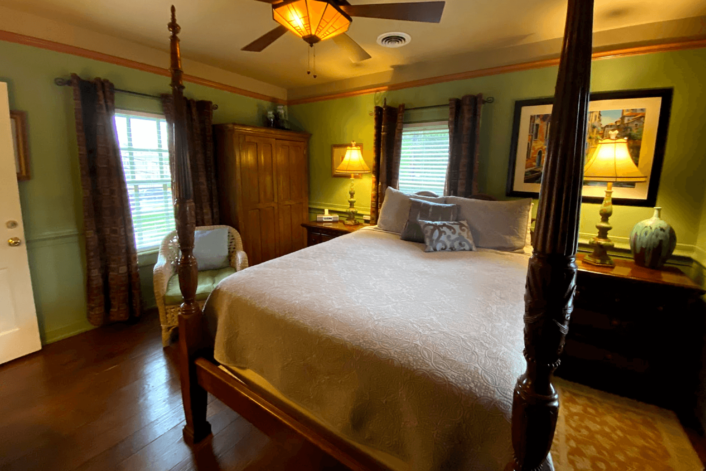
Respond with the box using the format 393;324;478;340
556;254;704;412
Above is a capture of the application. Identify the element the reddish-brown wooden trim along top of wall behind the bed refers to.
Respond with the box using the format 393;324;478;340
287;39;706;106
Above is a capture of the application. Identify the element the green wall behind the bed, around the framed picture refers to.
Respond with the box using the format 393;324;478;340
289;49;706;253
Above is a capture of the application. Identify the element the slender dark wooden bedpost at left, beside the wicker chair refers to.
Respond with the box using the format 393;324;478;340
168;5;211;444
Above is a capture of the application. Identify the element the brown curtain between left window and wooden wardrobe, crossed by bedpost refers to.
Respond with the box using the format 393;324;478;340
162;94;221;226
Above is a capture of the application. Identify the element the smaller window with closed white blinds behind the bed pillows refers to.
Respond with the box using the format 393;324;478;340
400;121;449;195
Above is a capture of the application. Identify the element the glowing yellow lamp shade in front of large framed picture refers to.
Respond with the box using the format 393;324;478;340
583;139;647;183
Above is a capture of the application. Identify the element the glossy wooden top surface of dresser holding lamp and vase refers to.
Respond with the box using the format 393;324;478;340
576;253;706;293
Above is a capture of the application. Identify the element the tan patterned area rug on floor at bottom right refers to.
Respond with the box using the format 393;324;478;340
552;378;704;471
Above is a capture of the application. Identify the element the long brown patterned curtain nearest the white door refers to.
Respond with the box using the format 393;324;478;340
71;74;140;325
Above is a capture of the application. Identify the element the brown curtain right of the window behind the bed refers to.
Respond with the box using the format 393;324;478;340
444;94;483;197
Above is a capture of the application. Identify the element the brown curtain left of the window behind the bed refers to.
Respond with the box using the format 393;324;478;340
370;105;404;224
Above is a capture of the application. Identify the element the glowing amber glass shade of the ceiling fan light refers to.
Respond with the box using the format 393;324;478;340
272;0;351;44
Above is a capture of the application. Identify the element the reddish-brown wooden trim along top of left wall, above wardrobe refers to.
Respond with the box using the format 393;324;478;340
0;30;287;105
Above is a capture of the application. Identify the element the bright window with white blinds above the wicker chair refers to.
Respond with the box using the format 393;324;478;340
115;112;174;251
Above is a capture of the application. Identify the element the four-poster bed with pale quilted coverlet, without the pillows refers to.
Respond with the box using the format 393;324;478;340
169;0;593;471
